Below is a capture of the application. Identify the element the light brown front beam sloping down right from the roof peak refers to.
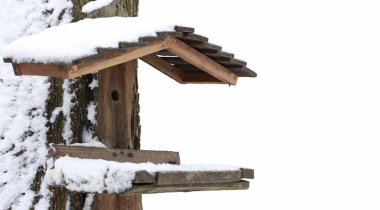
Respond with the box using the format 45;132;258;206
167;38;237;85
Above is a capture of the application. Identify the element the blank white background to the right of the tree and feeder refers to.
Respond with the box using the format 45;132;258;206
139;0;380;210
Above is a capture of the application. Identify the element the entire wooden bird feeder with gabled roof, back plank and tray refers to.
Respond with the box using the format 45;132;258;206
4;17;256;209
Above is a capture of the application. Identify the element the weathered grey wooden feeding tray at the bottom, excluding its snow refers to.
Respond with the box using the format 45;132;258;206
51;169;254;195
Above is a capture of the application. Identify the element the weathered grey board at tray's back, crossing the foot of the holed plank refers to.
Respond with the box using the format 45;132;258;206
49;145;180;164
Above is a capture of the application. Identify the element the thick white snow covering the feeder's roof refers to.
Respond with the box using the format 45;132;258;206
3;17;178;63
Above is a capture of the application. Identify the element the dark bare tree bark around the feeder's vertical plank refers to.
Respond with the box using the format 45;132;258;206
39;0;142;210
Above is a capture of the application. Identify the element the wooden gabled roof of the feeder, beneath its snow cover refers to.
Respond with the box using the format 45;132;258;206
4;17;256;85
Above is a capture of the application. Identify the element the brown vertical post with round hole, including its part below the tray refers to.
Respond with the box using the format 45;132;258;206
93;60;142;210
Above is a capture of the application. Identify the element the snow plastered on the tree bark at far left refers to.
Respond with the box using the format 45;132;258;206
0;0;72;210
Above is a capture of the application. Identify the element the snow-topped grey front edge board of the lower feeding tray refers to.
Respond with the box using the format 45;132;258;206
156;170;241;185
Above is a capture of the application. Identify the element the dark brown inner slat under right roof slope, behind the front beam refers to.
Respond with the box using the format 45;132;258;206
140;55;183;83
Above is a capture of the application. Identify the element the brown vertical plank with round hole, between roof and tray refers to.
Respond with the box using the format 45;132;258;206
98;60;136;149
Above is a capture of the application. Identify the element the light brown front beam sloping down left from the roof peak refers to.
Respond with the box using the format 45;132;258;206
69;39;170;78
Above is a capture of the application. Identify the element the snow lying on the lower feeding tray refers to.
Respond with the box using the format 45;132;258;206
45;156;239;193
